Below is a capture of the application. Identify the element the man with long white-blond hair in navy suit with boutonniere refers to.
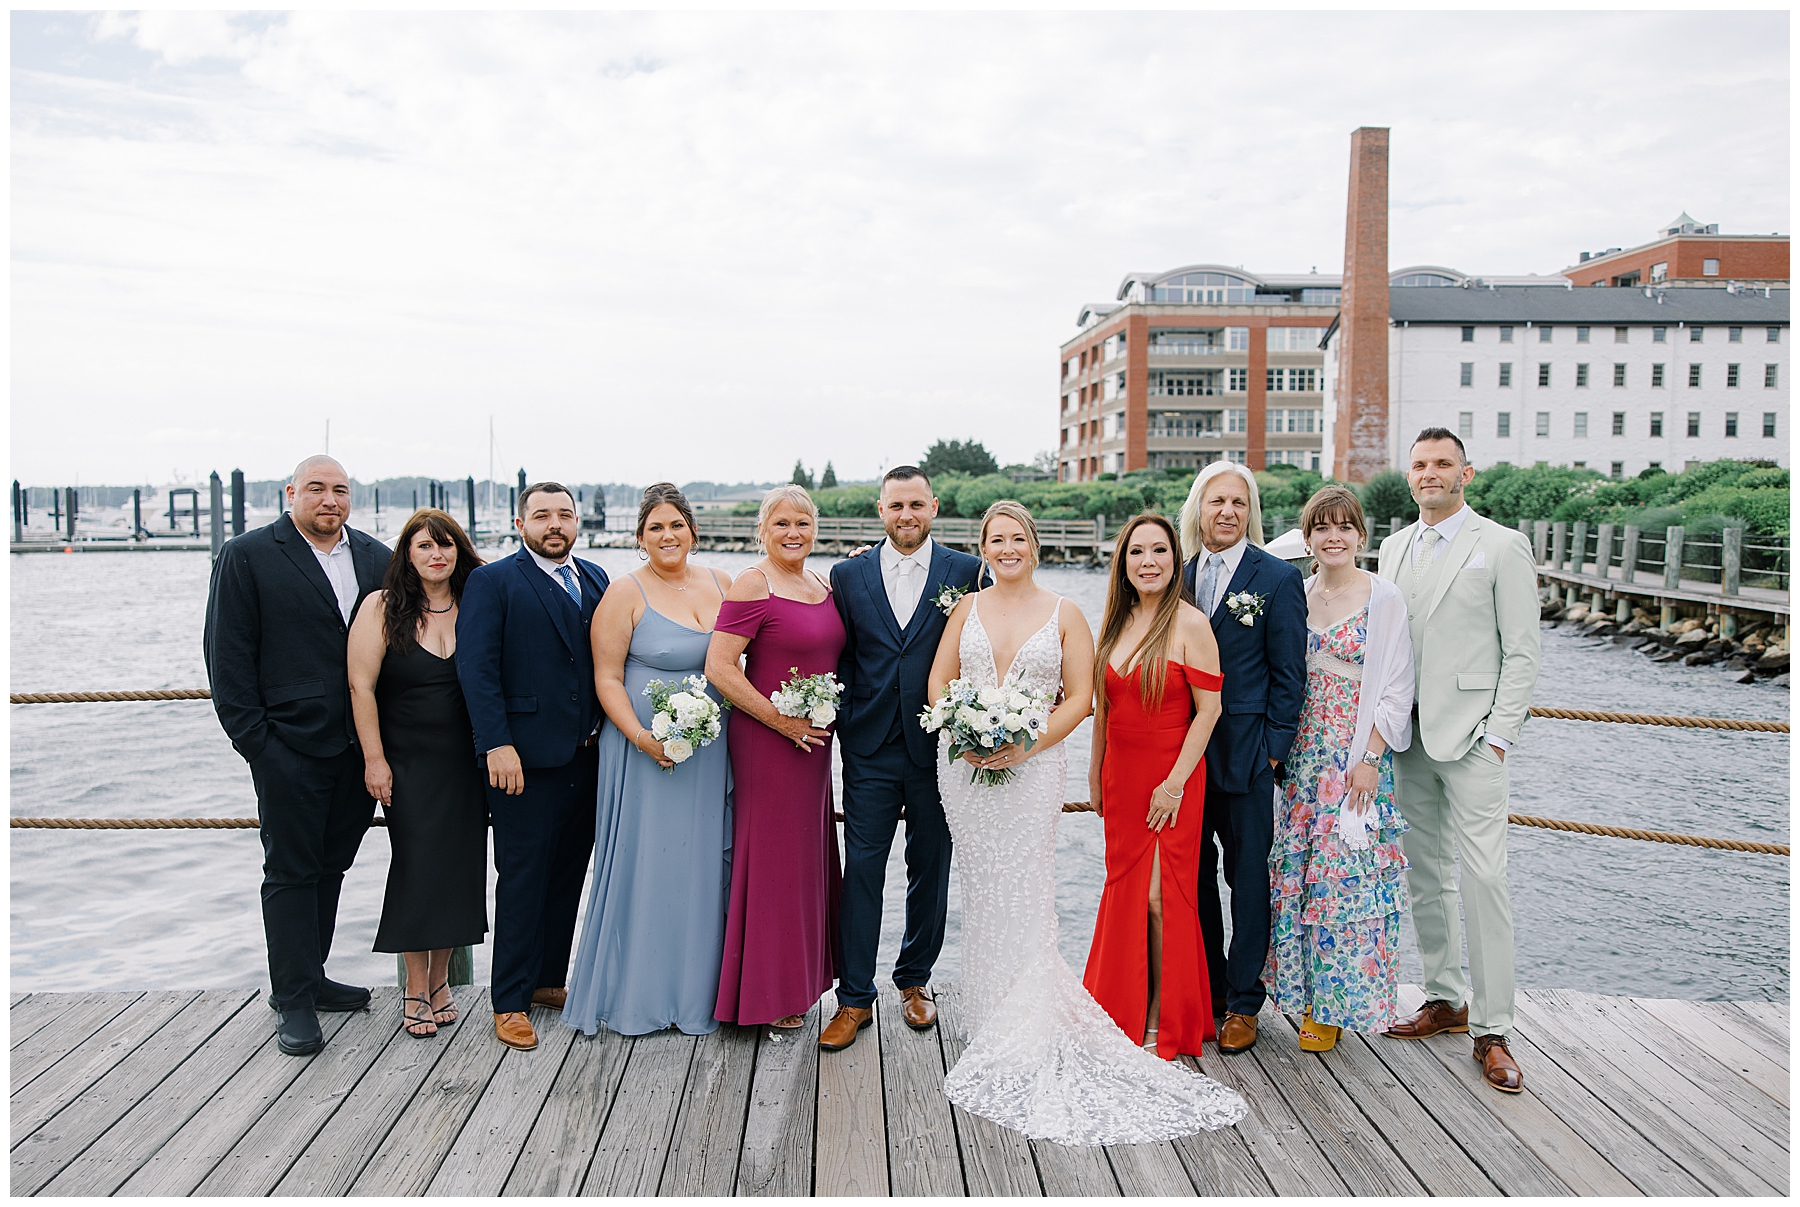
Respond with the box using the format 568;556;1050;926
1181;460;1307;1052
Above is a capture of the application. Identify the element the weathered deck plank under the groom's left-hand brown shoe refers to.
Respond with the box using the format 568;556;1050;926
812;993;887;1198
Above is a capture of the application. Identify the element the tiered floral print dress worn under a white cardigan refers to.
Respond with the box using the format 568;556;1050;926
1262;606;1408;1033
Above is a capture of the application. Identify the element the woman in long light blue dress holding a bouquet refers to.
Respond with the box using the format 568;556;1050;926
563;482;731;1034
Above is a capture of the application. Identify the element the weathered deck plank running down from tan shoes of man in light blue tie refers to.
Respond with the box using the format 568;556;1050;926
425;1006;576;1198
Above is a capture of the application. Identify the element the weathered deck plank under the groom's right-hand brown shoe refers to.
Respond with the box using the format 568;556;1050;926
875;988;967;1198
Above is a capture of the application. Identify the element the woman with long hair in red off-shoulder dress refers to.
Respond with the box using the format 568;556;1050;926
1084;514;1224;1059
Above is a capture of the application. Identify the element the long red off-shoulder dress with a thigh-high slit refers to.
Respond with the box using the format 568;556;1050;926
1084;662;1224;1059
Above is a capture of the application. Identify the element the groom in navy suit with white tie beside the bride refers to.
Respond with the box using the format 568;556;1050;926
819;466;981;1051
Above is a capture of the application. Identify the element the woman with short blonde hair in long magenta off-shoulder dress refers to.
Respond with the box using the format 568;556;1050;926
706;486;844;1031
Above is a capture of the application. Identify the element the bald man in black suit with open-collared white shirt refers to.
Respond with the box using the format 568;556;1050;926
205;457;389;1056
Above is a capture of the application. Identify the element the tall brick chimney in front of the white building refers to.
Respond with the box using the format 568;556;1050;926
1332;126;1388;482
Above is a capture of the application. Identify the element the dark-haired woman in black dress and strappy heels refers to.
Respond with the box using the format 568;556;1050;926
349;507;488;1040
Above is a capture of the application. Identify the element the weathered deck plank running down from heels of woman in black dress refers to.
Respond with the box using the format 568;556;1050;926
270;992;475;1198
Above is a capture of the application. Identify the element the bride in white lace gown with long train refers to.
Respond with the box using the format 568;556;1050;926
931;500;1246;1144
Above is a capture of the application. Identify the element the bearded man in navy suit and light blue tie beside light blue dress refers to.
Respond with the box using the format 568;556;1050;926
455;482;607;1049
